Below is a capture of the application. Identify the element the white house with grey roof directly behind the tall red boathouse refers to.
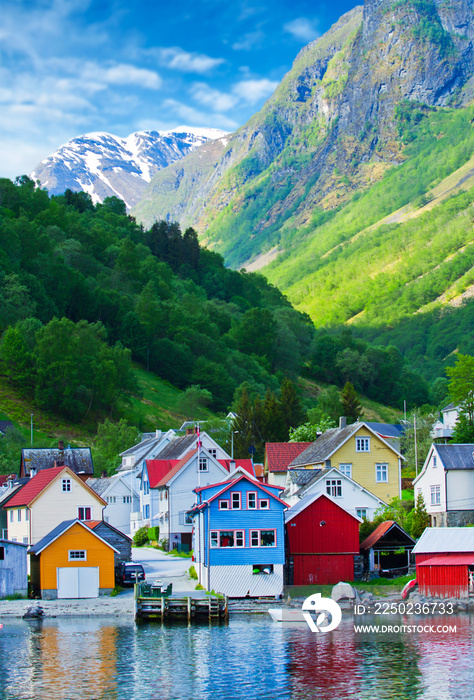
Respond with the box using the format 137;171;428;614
281;467;386;520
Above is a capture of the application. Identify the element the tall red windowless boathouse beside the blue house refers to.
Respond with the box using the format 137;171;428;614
285;493;362;586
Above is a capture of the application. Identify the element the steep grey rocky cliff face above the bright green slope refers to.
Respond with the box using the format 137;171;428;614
133;0;474;265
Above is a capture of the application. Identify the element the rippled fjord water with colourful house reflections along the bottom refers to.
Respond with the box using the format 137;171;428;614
0;613;474;700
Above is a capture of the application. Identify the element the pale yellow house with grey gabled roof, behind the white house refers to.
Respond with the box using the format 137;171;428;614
288;422;403;503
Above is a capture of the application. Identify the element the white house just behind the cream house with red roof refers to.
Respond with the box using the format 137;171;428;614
86;470;140;535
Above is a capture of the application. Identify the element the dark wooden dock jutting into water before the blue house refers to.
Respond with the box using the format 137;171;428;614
135;584;229;622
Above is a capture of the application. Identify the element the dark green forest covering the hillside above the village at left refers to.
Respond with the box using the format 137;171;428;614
0;177;448;430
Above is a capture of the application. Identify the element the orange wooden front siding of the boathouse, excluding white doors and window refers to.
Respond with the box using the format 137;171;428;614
39;523;115;590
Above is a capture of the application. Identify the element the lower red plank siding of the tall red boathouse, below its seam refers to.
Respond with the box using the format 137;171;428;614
293;554;354;586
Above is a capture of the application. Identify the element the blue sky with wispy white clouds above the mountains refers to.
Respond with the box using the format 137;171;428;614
0;0;357;179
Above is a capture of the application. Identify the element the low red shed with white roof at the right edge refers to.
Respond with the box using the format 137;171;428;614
413;527;474;598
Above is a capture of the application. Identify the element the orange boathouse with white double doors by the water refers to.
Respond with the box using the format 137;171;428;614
28;519;117;599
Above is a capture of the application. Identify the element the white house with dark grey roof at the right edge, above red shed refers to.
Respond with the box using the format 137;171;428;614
413;444;474;527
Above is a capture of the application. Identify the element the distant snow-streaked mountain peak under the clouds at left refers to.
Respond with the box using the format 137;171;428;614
30;127;225;208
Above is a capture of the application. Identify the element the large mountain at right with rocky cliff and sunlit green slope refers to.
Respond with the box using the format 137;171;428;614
131;0;474;325
